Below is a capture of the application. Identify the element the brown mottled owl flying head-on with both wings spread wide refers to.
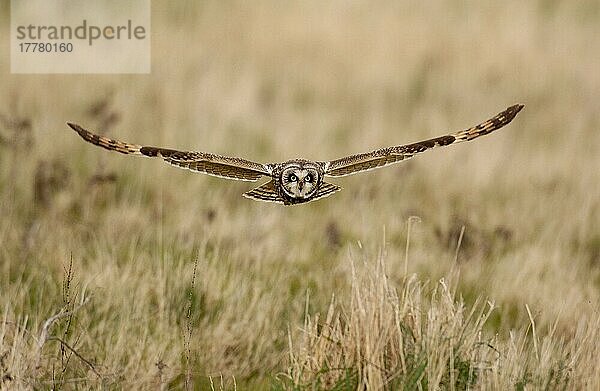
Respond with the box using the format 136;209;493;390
67;104;523;205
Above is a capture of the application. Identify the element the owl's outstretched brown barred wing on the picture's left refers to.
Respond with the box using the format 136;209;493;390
67;122;271;181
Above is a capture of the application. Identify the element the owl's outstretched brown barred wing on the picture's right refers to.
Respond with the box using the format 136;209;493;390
322;104;523;177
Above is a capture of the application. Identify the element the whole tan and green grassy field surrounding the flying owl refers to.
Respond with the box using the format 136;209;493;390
0;0;600;390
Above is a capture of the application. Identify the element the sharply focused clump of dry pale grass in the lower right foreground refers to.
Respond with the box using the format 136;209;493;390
281;259;600;390
